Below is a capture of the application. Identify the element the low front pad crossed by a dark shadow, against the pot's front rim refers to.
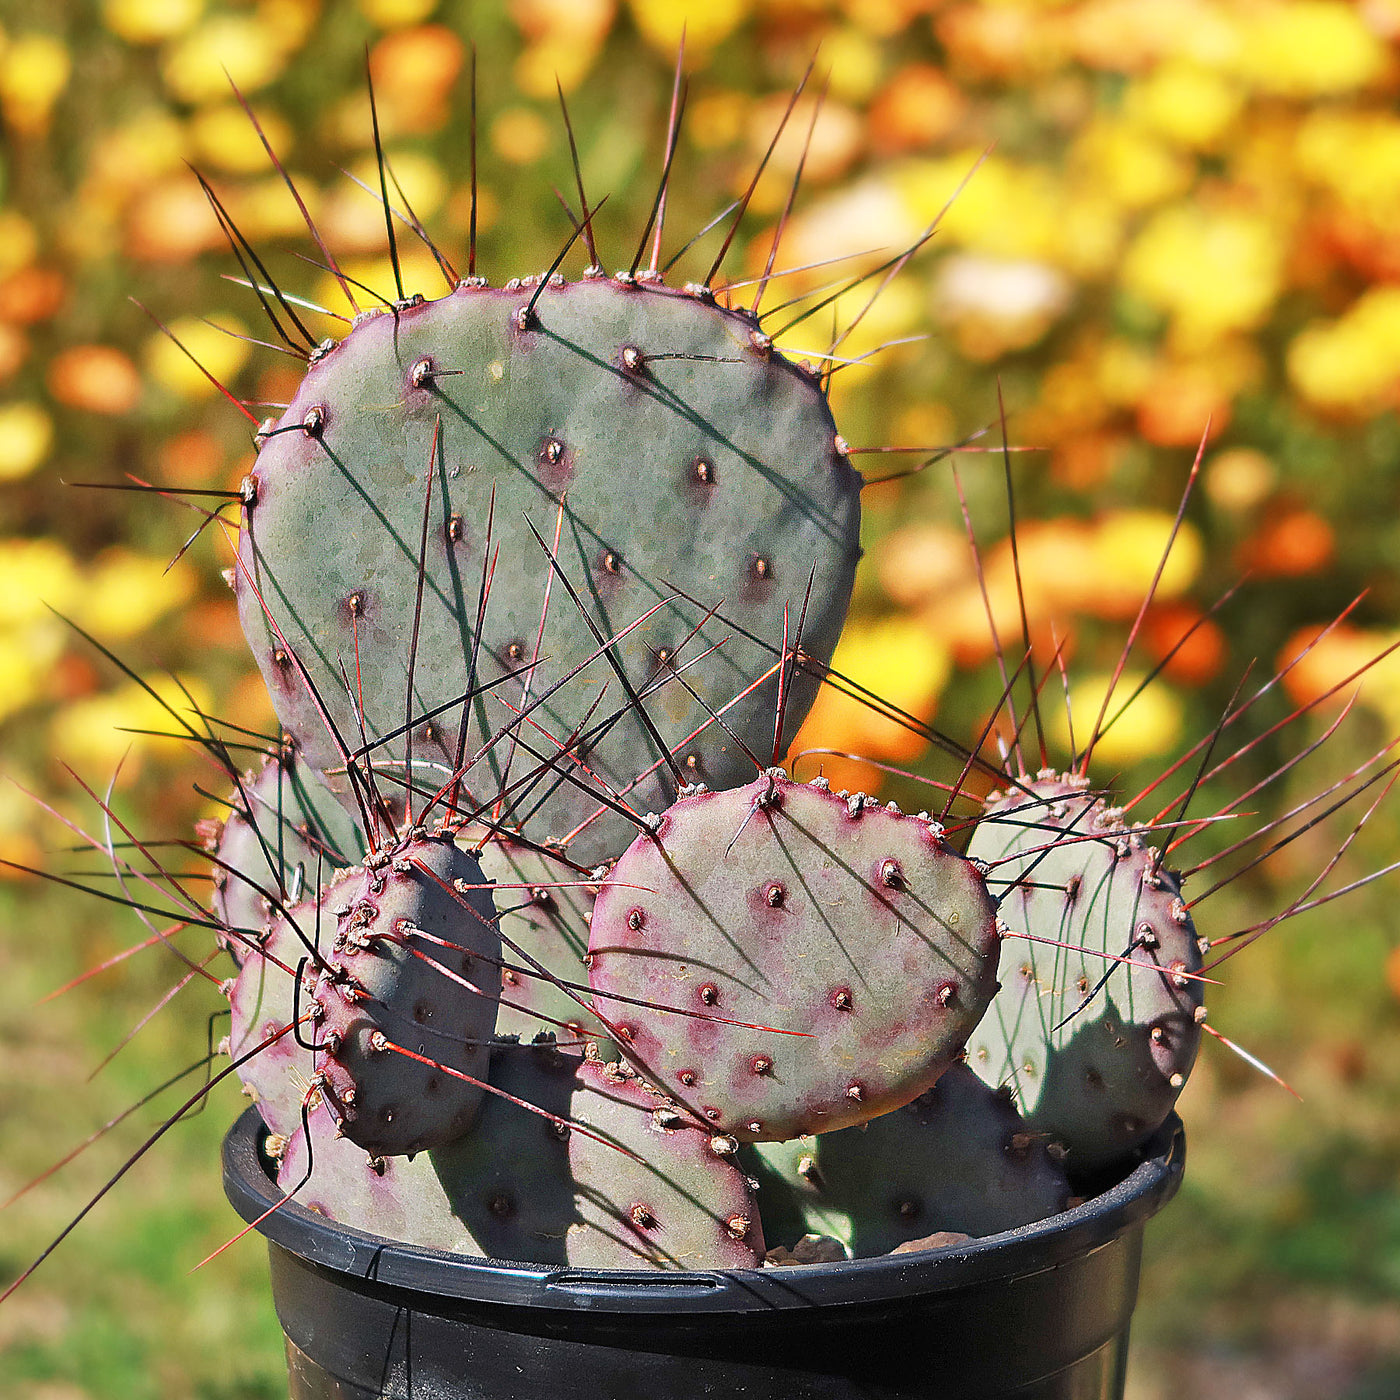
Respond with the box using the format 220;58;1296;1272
277;1040;763;1268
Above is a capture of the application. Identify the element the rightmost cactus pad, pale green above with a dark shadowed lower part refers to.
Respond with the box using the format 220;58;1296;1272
967;776;1204;1172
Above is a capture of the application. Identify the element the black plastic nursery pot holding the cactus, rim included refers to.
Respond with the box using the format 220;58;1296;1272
224;1109;1186;1400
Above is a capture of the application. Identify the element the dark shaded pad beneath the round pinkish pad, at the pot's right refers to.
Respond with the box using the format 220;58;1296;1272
743;1064;1070;1259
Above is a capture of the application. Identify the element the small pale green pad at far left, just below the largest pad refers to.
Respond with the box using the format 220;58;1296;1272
213;752;364;965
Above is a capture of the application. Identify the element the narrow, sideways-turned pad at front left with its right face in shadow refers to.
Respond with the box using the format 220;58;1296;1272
312;836;501;1156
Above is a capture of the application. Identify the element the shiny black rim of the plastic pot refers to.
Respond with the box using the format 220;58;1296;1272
223;1107;1186;1313
